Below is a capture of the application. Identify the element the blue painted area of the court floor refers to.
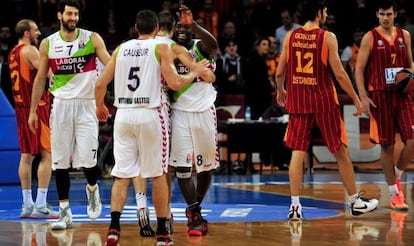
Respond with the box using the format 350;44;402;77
0;174;352;223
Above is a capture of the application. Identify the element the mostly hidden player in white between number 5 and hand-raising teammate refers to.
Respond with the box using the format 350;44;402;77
133;11;216;237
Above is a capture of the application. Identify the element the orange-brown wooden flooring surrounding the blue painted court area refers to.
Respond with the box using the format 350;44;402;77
0;170;414;246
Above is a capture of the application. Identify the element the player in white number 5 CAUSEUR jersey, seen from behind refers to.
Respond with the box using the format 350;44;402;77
95;10;209;246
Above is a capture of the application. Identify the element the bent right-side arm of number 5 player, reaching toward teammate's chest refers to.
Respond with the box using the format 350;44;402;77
157;44;209;90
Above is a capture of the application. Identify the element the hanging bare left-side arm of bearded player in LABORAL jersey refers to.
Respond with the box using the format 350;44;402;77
28;38;49;132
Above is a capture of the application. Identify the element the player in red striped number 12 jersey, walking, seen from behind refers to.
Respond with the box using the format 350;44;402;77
276;0;378;220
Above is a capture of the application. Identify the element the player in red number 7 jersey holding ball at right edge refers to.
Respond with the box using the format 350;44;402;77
355;0;414;210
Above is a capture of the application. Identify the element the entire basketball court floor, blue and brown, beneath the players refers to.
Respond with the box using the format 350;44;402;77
0;170;414;246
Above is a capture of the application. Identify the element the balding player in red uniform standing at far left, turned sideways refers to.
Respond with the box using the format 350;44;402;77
9;19;58;219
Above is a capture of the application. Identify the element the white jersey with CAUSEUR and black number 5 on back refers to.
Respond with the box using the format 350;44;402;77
114;39;166;108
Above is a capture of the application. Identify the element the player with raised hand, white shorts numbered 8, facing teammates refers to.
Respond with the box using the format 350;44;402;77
170;5;219;236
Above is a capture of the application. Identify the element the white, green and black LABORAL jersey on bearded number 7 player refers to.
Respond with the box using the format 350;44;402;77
47;28;98;99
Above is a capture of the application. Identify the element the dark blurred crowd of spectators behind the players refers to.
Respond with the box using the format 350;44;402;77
0;0;414;109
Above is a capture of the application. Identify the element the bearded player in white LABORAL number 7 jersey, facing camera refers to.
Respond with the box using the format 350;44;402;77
29;0;110;230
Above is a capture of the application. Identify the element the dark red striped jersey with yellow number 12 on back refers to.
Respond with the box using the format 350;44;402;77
286;27;338;113
